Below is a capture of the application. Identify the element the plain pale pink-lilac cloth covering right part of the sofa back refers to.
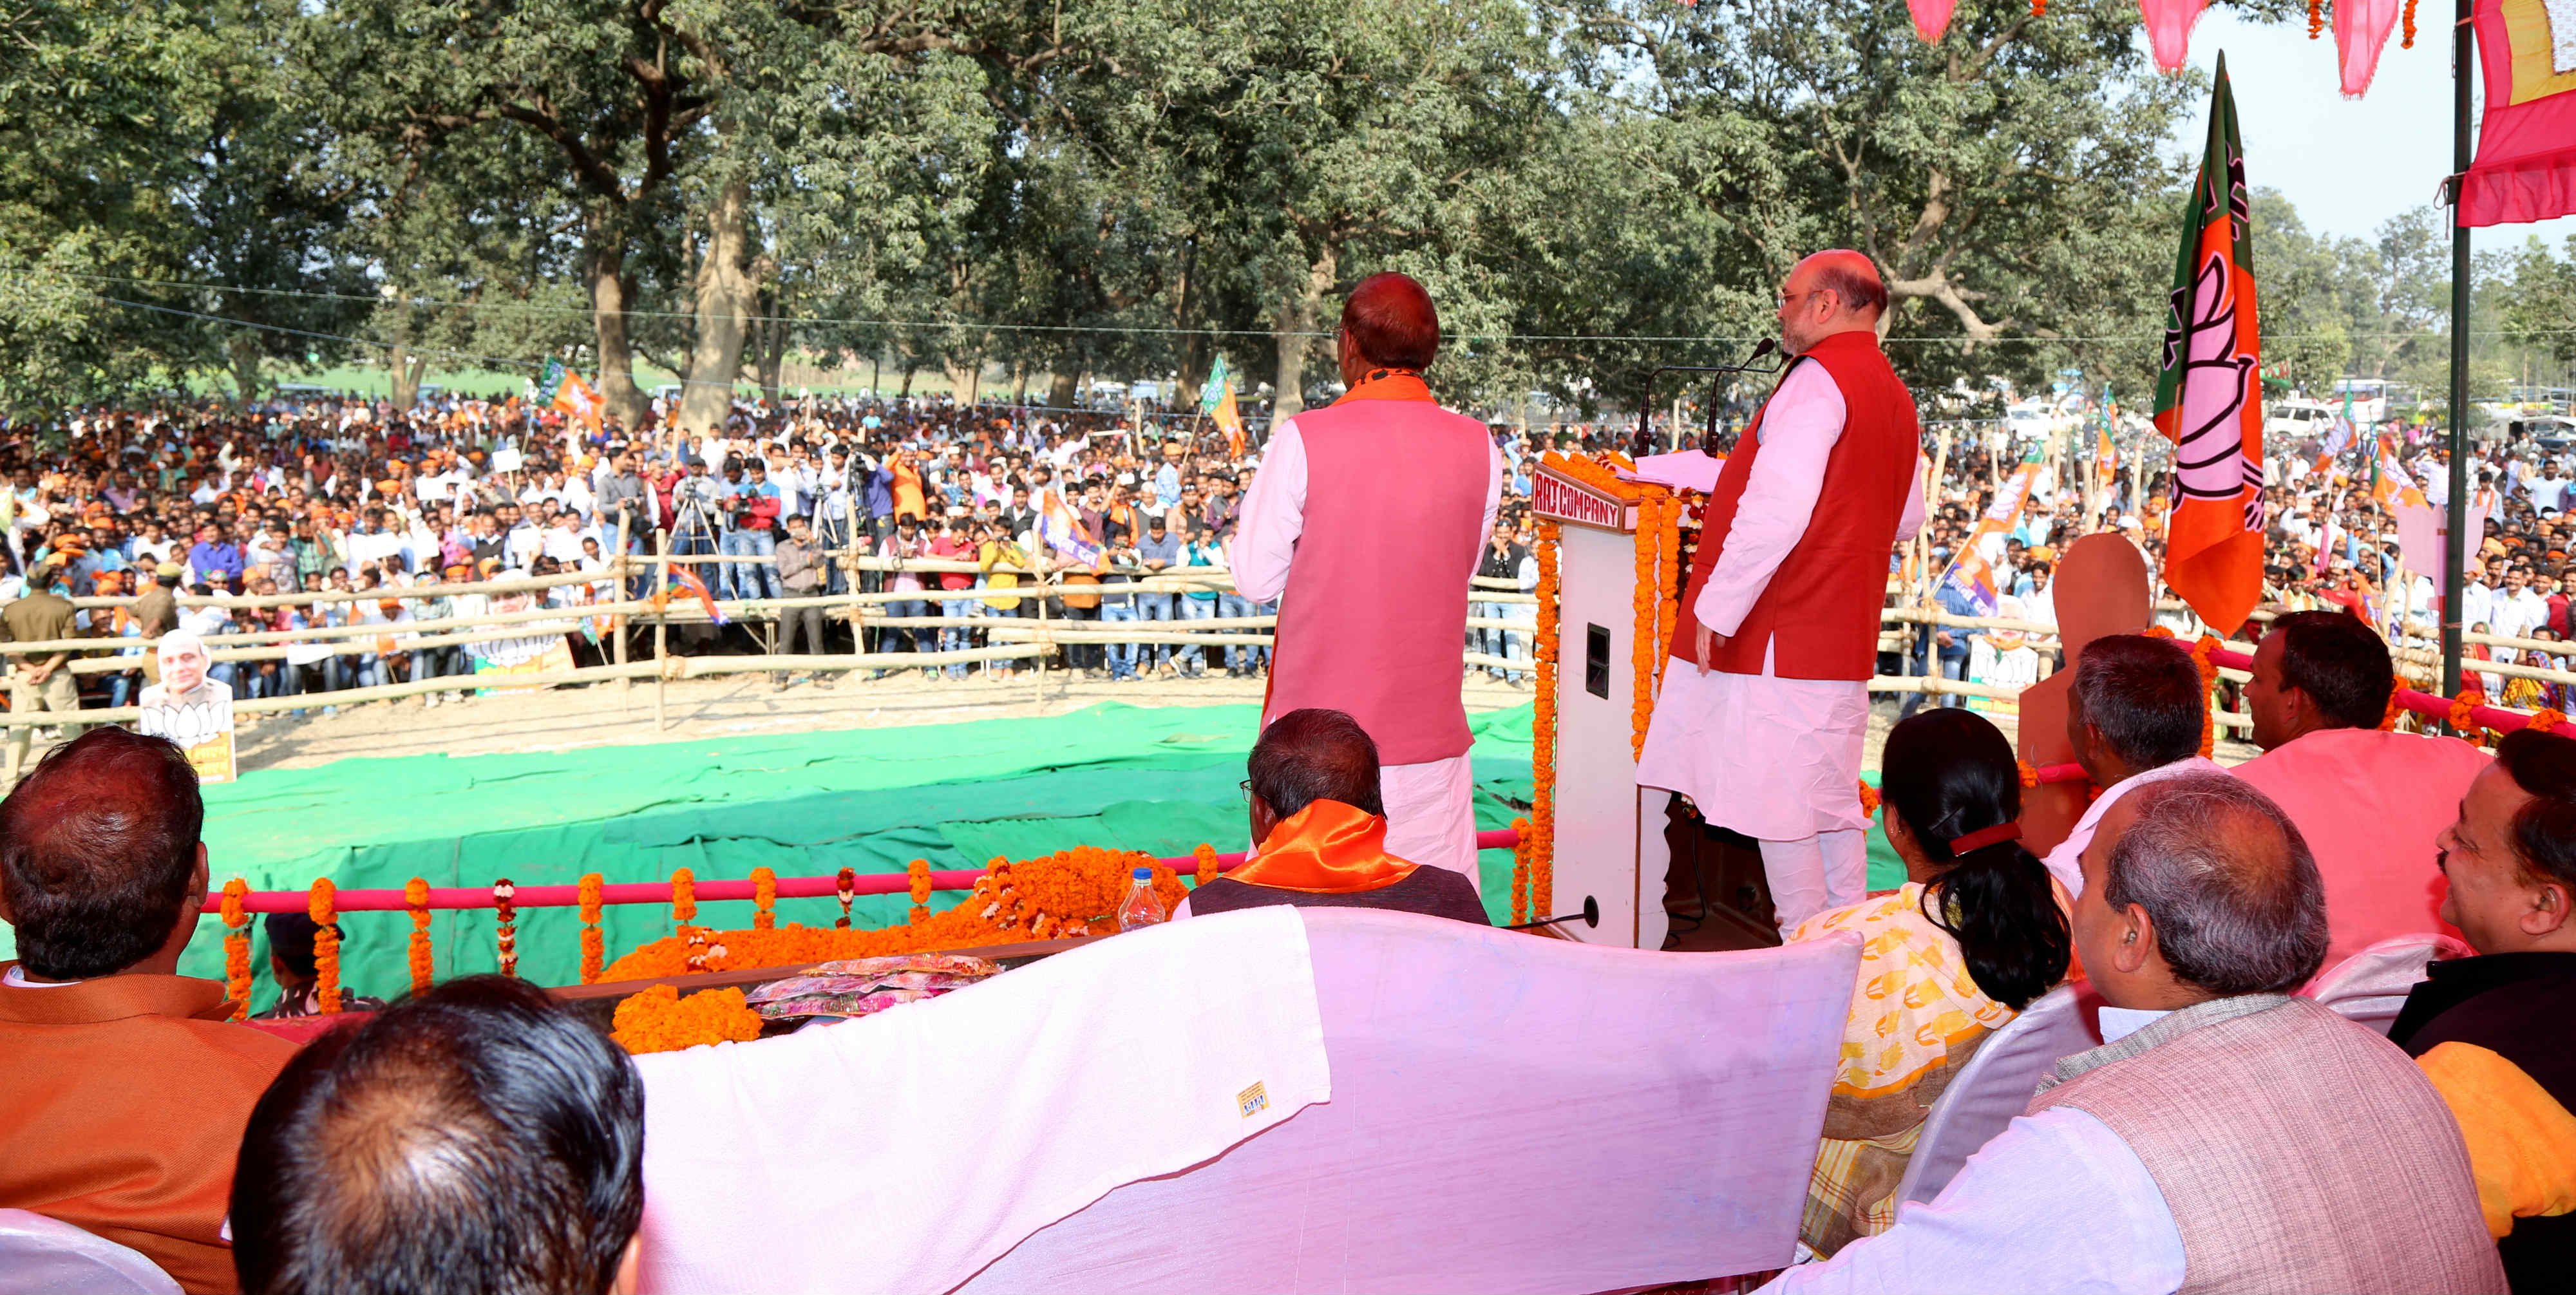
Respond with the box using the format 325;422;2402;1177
958;909;1860;1295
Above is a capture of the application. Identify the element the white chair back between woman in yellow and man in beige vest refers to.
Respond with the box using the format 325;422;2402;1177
1896;981;2102;1207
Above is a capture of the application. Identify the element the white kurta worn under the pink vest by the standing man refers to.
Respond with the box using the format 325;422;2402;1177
1226;417;1504;888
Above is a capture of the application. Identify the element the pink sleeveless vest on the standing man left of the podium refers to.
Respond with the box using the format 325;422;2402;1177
1262;399;1494;764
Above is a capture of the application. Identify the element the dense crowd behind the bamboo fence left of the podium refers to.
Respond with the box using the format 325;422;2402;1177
0;397;1546;710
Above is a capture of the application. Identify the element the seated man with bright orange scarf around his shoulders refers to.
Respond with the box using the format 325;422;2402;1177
1172;708;1492;927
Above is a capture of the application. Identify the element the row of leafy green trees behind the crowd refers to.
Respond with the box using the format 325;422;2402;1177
0;0;2576;425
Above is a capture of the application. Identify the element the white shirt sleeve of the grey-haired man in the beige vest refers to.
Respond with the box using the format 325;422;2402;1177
1762;1107;2184;1295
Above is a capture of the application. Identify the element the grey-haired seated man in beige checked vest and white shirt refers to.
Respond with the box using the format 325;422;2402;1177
1767;777;2504;1292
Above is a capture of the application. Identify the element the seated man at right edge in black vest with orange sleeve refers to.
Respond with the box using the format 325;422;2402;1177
2388;728;2576;1292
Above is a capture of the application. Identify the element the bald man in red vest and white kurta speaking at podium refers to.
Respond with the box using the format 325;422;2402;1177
1636;252;1922;929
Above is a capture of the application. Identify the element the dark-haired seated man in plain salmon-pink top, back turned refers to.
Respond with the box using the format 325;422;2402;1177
2233;613;2491;965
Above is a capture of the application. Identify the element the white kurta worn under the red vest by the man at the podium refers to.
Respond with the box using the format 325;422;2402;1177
1636;363;1924;842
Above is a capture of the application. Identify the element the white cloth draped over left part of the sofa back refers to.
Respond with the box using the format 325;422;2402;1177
636;906;1332;1295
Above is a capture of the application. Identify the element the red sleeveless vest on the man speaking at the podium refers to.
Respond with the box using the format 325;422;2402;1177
1667;332;1922;679
